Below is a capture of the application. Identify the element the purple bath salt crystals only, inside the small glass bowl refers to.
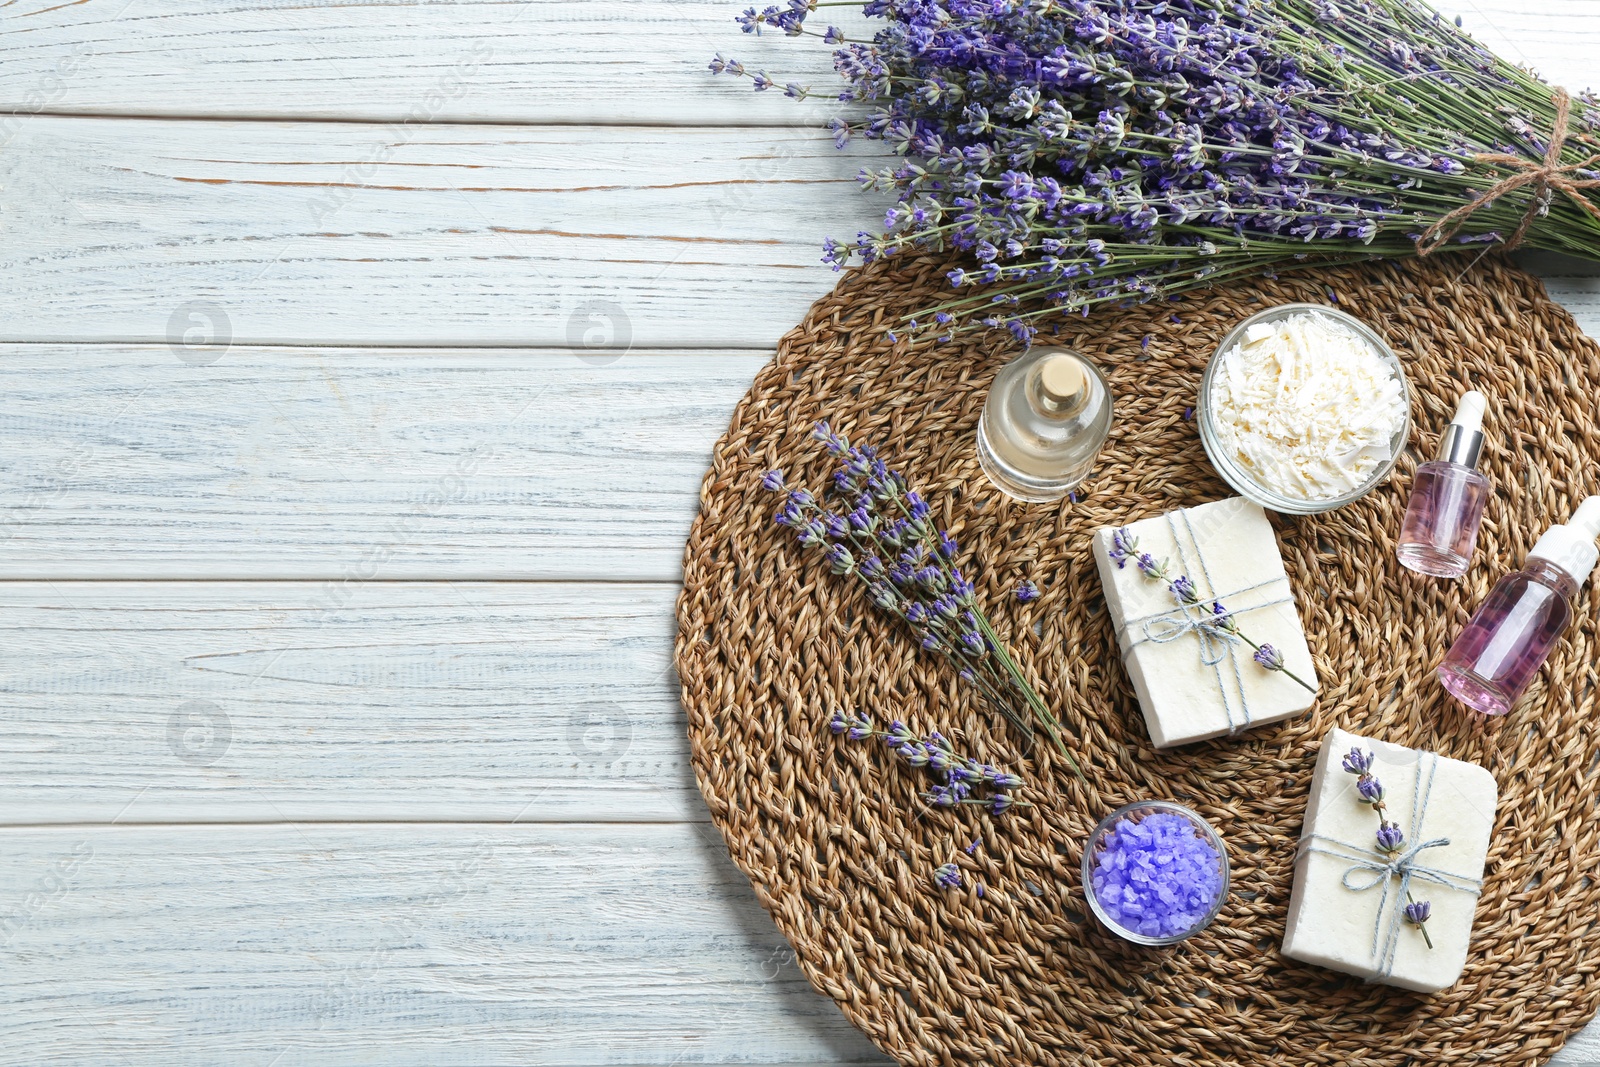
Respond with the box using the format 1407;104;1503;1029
1093;811;1222;937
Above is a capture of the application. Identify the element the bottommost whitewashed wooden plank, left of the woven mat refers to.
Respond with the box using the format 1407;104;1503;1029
0;824;886;1067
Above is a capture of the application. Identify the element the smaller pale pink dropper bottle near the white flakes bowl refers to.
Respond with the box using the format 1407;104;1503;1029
1395;389;1490;577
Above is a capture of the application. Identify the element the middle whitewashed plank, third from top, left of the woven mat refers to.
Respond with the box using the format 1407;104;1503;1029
0;346;770;581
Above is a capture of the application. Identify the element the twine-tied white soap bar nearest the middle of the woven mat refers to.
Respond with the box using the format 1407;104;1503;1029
1094;496;1317;749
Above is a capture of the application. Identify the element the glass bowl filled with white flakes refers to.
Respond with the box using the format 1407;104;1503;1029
1198;304;1411;515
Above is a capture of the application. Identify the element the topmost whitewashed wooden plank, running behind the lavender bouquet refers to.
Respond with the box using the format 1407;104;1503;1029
0;0;1600;123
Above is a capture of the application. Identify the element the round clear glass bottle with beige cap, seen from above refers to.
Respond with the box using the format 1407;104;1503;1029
978;347;1112;502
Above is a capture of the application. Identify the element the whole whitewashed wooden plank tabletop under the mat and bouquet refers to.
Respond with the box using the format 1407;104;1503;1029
0;0;1600;1067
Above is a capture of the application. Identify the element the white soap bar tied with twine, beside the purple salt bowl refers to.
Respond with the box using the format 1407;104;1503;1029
1283;728;1498;993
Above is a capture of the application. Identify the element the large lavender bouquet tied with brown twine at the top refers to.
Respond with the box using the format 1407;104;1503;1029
712;0;1600;339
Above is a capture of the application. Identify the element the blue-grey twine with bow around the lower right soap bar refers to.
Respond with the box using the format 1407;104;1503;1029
1299;752;1483;977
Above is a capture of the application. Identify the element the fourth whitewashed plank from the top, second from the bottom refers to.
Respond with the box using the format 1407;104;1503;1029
0;581;707;825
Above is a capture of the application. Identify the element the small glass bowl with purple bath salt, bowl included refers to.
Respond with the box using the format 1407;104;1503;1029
1083;800;1227;945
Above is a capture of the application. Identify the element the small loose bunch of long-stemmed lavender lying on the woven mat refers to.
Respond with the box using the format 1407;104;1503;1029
762;422;1083;779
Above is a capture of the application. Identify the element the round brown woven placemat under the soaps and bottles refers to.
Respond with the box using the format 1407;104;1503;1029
677;256;1600;1067
